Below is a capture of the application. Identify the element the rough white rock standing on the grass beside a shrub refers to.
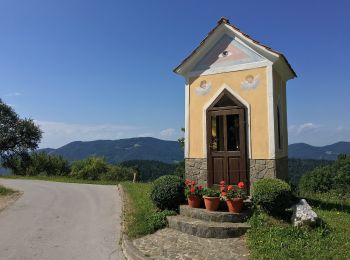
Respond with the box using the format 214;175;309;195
291;199;318;226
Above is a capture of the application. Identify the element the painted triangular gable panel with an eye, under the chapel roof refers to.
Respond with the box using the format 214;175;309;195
194;34;263;71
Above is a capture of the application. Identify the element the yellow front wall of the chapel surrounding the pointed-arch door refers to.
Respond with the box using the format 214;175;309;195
188;67;269;159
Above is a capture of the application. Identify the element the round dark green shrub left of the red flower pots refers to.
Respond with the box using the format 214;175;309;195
151;175;185;210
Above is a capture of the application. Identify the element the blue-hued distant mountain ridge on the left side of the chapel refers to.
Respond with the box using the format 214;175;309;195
38;137;184;163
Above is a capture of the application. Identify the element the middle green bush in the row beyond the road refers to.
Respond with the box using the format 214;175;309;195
70;157;108;180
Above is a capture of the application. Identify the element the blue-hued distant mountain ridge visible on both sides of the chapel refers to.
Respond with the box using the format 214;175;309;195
38;137;350;163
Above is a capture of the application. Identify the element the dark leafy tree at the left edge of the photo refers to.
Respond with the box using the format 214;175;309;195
0;99;42;168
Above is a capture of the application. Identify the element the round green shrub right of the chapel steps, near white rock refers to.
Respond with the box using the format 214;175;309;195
252;179;292;215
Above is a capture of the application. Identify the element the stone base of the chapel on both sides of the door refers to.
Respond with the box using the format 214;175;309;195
185;157;289;187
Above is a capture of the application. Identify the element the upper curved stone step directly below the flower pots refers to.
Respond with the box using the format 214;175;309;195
180;205;250;223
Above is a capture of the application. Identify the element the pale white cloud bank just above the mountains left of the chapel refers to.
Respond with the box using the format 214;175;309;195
35;120;144;148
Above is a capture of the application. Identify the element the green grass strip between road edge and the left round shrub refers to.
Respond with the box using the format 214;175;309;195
121;182;157;238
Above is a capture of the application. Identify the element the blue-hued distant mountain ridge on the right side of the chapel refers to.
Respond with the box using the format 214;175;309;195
288;142;350;160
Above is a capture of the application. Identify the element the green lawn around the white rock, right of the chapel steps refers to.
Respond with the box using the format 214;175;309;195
247;195;350;259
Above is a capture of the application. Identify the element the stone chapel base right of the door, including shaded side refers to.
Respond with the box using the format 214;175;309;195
249;157;289;187
